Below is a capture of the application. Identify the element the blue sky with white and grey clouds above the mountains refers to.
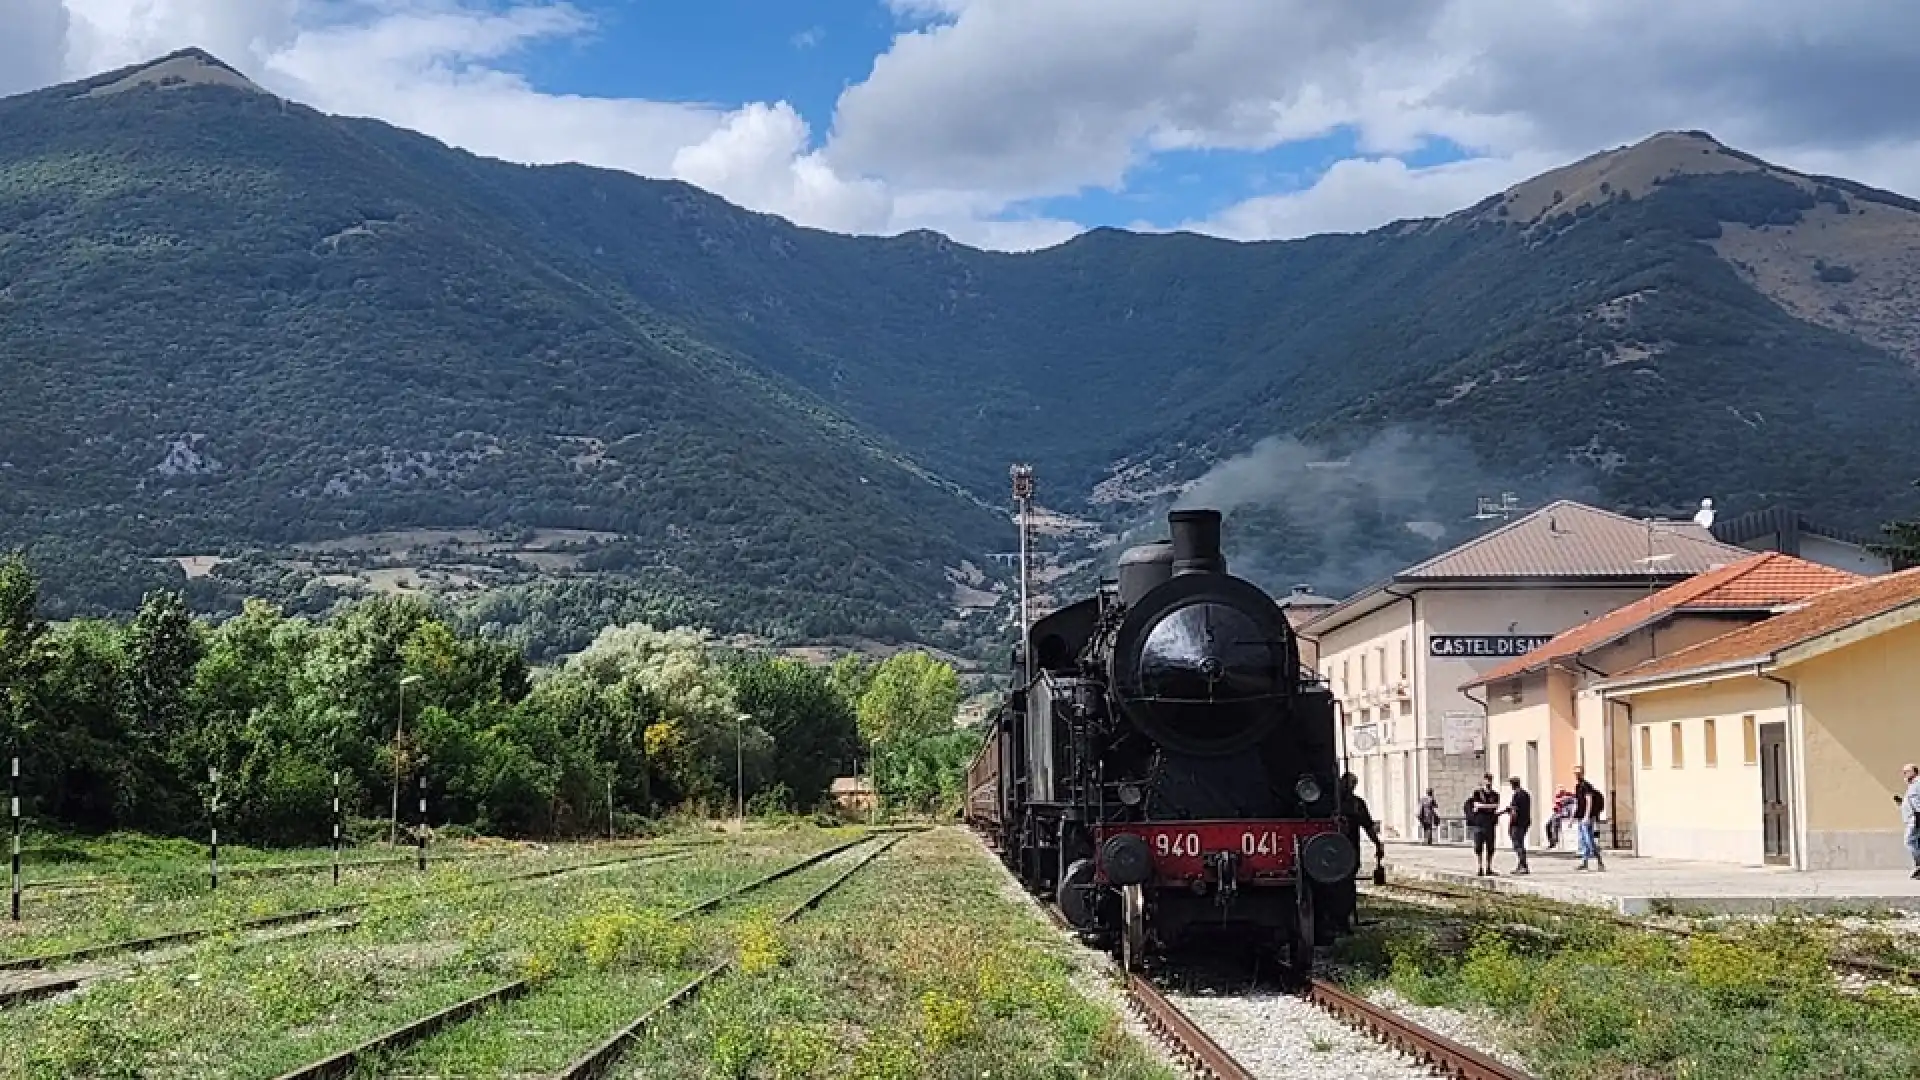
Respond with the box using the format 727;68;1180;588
0;0;1920;250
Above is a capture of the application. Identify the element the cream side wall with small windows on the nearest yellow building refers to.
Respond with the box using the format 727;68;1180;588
1628;676;1774;867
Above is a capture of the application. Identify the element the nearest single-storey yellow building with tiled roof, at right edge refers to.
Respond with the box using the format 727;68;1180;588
1594;569;1920;871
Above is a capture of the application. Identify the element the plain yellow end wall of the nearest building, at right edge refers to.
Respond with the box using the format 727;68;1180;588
1776;623;1920;869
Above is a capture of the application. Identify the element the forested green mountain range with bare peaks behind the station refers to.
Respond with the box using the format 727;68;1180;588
0;50;1920;648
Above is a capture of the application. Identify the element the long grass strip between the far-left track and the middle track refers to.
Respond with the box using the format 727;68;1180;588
0;818;856;1080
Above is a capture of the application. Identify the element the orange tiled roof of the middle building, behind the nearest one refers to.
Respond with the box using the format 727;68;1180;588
1461;552;1864;690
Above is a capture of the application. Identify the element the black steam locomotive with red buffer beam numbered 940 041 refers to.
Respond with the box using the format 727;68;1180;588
966;509;1359;970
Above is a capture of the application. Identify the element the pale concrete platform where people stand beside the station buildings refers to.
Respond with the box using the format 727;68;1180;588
1361;842;1920;915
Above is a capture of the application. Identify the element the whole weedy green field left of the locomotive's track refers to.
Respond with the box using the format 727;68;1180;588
0;824;1169;1080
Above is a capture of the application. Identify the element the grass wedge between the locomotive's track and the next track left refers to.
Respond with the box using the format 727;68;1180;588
622;828;1173;1080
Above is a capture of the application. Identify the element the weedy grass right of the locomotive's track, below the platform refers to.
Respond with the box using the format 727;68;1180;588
1338;891;1920;1080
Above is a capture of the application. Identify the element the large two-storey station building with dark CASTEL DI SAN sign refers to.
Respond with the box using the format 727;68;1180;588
1300;502;1751;838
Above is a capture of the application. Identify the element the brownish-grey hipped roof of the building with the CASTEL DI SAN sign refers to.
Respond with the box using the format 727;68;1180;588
1394;500;1753;582
